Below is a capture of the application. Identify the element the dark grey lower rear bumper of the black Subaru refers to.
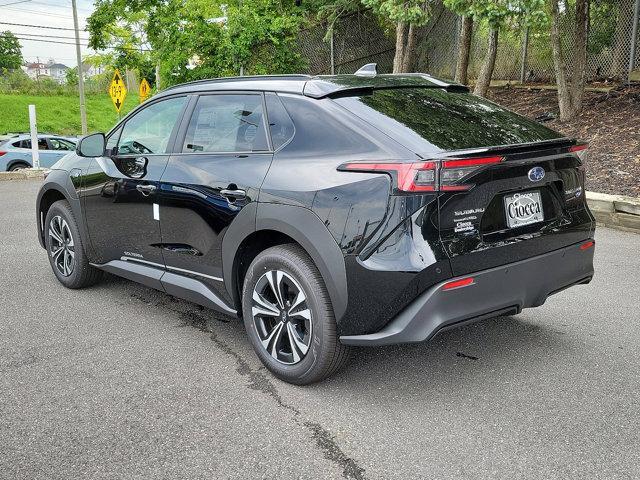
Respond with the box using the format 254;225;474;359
340;242;594;346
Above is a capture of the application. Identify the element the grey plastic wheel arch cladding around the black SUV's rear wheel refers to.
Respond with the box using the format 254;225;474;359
222;203;347;321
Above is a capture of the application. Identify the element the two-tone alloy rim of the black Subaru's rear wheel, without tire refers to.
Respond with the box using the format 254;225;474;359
251;270;313;365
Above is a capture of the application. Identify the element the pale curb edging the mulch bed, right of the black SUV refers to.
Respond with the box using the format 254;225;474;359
587;192;640;233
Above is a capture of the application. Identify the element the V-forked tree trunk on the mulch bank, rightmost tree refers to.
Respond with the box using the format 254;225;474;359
549;0;589;121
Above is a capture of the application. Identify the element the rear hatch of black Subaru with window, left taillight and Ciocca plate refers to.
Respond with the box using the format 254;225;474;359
334;87;594;276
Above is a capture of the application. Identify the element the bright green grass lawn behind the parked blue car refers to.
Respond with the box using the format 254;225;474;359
0;93;138;135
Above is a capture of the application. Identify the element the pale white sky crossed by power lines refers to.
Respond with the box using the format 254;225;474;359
0;0;93;67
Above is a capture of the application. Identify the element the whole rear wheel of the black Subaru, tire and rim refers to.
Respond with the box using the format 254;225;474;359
242;244;349;385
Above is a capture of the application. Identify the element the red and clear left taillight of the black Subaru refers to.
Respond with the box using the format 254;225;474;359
339;156;504;192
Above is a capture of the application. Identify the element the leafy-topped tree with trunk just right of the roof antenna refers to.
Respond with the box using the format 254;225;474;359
362;0;431;73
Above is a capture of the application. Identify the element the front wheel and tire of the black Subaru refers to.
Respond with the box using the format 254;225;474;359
44;200;102;288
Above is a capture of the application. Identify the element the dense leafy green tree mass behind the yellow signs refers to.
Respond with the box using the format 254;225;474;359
87;0;304;85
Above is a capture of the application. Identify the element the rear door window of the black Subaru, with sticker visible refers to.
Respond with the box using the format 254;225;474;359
182;94;269;152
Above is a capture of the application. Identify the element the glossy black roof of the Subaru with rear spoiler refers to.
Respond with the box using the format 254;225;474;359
162;73;468;98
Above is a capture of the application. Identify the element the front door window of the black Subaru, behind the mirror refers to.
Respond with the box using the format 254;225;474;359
118;97;186;155
